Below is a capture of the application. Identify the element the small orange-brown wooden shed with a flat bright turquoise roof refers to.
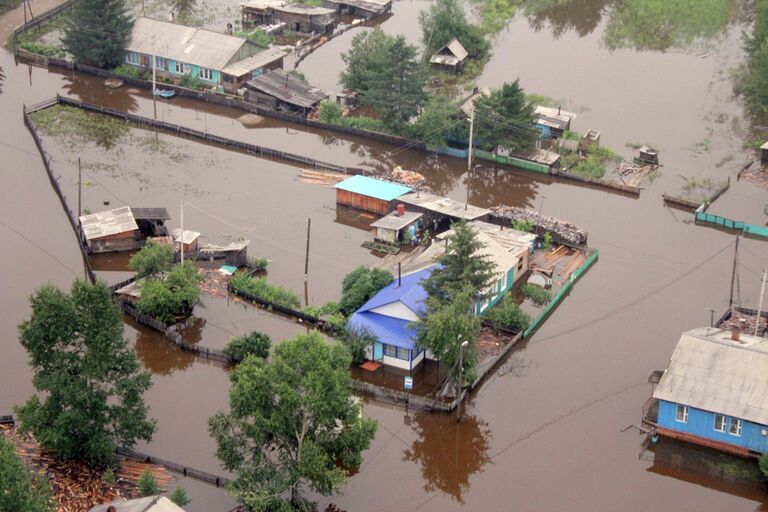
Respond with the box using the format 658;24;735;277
334;175;411;215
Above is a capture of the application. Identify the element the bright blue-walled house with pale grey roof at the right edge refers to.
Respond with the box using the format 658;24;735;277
653;327;768;456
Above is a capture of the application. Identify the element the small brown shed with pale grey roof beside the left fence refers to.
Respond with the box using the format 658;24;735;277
80;206;144;253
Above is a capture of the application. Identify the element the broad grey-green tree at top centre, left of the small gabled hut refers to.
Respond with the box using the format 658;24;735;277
341;27;427;132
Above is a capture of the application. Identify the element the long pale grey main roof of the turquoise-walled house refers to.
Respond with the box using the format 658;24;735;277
126;18;258;70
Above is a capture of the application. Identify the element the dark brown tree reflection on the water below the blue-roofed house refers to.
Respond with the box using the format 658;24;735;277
403;412;491;503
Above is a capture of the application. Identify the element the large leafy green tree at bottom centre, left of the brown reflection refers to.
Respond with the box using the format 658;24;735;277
208;333;376;511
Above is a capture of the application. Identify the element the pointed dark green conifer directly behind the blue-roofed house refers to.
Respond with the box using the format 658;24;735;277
423;220;496;303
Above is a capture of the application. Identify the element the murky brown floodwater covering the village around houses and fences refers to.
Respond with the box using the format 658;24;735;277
0;2;768;512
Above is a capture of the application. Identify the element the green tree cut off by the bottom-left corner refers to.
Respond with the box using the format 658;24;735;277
0;434;55;512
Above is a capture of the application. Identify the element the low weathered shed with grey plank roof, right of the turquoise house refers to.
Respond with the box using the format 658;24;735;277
247;69;328;115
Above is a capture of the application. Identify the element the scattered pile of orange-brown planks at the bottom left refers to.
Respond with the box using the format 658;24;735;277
0;425;171;512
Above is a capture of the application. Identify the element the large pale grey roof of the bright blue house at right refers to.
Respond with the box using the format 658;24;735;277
653;327;768;425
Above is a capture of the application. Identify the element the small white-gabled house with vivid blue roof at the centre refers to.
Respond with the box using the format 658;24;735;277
347;267;434;371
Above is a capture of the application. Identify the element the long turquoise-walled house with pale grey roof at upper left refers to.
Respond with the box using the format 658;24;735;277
125;18;285;93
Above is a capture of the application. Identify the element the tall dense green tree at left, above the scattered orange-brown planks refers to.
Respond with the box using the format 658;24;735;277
16;280;155;468
